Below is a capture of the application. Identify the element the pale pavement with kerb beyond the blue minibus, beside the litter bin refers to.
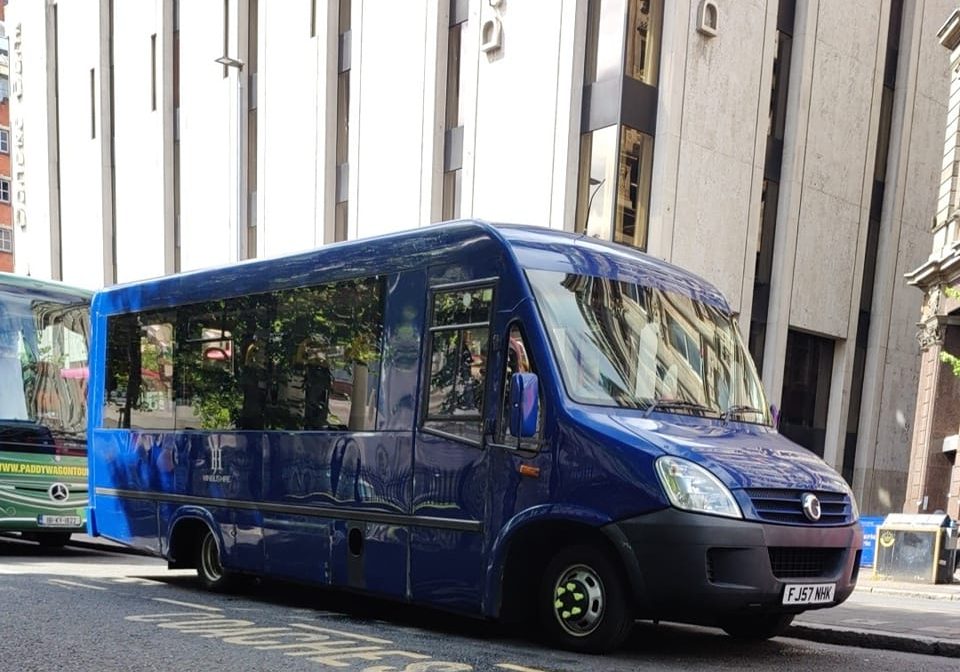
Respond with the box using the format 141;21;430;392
71;534;960;669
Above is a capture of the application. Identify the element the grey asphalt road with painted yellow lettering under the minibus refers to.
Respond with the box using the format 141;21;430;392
0;537;957;672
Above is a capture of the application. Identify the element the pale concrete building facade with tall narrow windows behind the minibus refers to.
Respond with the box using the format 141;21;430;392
8;0;952;513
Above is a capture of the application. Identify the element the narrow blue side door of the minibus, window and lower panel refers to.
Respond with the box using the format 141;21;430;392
410;281;494;611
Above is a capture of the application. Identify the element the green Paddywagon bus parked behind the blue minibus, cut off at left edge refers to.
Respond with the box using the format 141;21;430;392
0;273;91;546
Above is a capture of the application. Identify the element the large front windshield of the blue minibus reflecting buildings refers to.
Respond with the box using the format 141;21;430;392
526;269;770;424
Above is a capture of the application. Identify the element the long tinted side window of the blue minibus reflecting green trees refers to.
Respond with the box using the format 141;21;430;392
103;276;383;431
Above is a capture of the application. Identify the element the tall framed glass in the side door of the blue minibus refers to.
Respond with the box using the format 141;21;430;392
423;287;493;444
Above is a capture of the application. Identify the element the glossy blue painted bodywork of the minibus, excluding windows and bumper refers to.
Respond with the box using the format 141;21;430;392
89;222;860;615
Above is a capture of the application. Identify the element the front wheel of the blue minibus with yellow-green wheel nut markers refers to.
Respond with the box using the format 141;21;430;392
537;546;633;653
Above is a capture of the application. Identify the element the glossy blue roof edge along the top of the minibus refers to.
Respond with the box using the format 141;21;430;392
94;220;729;314
